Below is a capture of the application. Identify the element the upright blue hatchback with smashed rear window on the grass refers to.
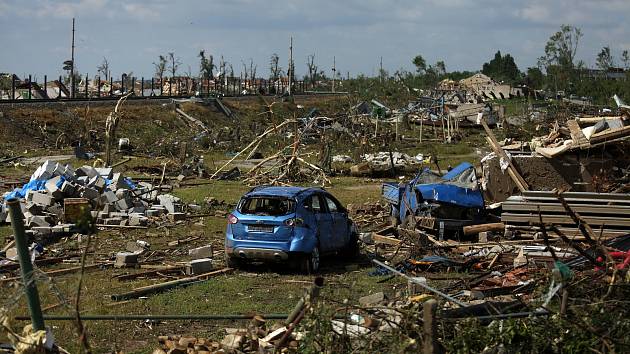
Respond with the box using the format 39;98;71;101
225;186;358;273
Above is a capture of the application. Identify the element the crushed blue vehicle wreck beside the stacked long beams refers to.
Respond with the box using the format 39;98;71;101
382;162;488;239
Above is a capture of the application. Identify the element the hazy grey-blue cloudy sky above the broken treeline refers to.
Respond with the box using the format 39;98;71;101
0;0;630;78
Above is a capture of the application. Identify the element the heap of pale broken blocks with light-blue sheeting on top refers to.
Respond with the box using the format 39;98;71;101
0;161;185;236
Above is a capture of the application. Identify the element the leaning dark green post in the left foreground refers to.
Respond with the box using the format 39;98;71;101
7;198;46;331
